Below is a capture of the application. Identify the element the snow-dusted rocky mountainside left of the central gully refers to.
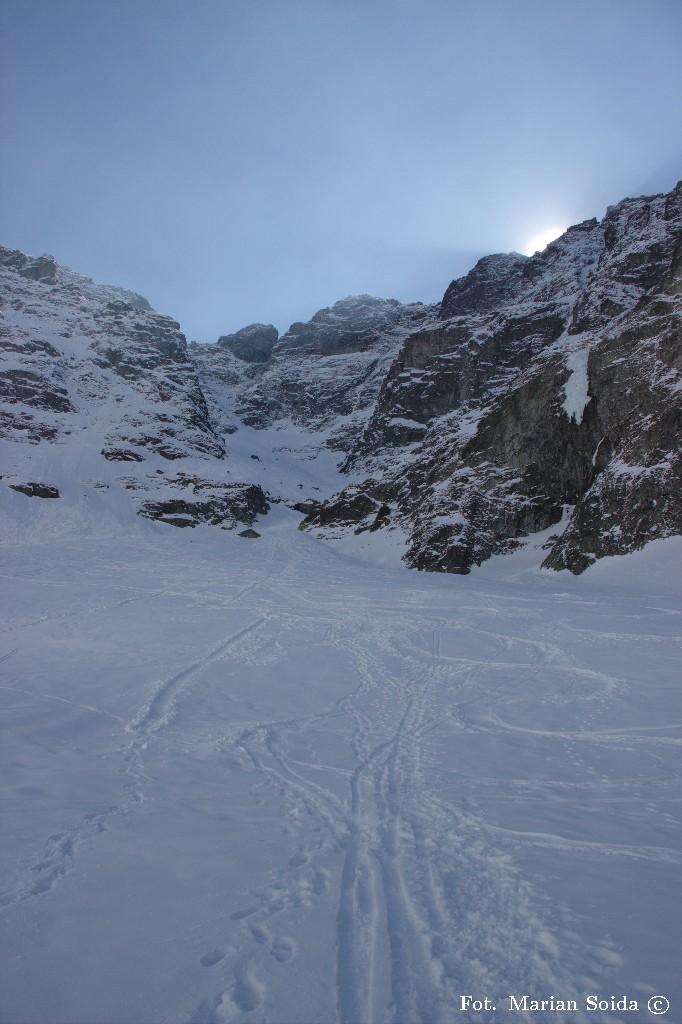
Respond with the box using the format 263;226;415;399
0;249;267;528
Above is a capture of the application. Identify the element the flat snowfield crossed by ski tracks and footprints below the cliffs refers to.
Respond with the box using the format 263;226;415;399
0;520;682;1024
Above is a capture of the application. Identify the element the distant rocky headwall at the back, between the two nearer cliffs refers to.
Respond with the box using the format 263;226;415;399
190;295;435;452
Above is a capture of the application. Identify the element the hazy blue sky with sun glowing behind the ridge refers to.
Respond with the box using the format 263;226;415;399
0;0;682;341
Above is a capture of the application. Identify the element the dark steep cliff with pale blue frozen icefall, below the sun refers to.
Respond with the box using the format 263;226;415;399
306;186;682;572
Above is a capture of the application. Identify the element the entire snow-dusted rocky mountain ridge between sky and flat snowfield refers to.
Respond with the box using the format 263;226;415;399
0;184;682;573
